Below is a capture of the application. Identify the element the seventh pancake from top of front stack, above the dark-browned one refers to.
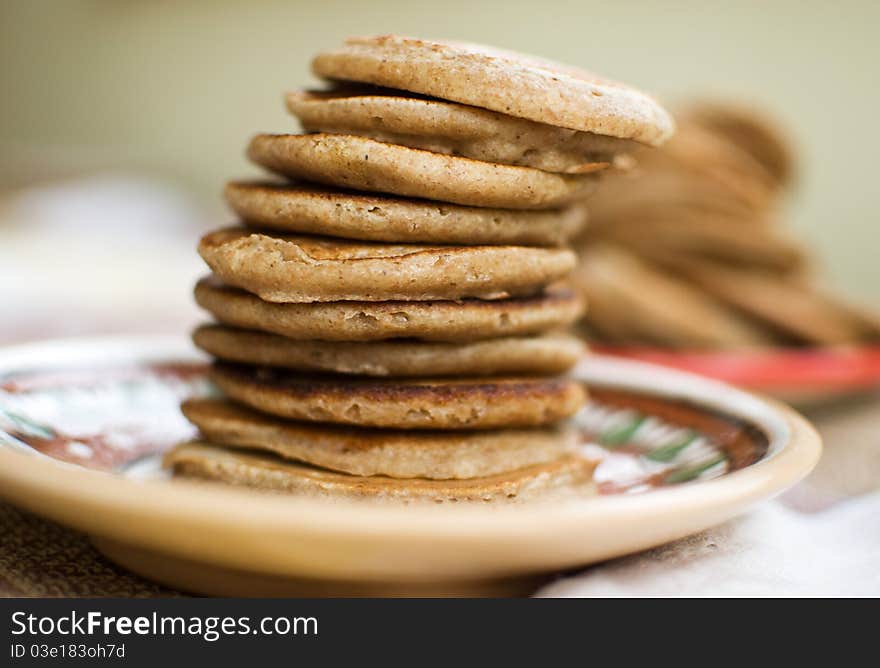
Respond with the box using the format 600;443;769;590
193;325;584;377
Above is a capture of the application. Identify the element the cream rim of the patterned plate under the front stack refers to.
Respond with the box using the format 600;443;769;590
0;335;821;573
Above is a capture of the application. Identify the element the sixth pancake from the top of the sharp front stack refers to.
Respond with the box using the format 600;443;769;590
195;277;583;341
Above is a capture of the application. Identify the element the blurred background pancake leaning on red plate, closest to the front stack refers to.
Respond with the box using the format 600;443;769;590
575;244;771;348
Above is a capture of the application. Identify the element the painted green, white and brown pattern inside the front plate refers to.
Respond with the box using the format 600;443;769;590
0;362;767;494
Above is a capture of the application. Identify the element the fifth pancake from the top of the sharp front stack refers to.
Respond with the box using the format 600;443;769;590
199;228;577;303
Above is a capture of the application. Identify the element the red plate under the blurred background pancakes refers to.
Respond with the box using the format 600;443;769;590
595;345;880;406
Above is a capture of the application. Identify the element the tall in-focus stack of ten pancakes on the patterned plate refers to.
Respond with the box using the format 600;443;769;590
166;32;671;501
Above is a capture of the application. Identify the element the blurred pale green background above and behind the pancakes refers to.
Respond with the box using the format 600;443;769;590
0;0;880;303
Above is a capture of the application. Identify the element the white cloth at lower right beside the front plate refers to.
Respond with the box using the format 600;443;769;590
537;493;880;597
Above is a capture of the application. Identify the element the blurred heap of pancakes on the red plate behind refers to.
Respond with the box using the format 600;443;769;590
577;104;880;349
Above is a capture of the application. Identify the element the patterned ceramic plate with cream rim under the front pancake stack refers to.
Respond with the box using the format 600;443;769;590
0;338;820;595
